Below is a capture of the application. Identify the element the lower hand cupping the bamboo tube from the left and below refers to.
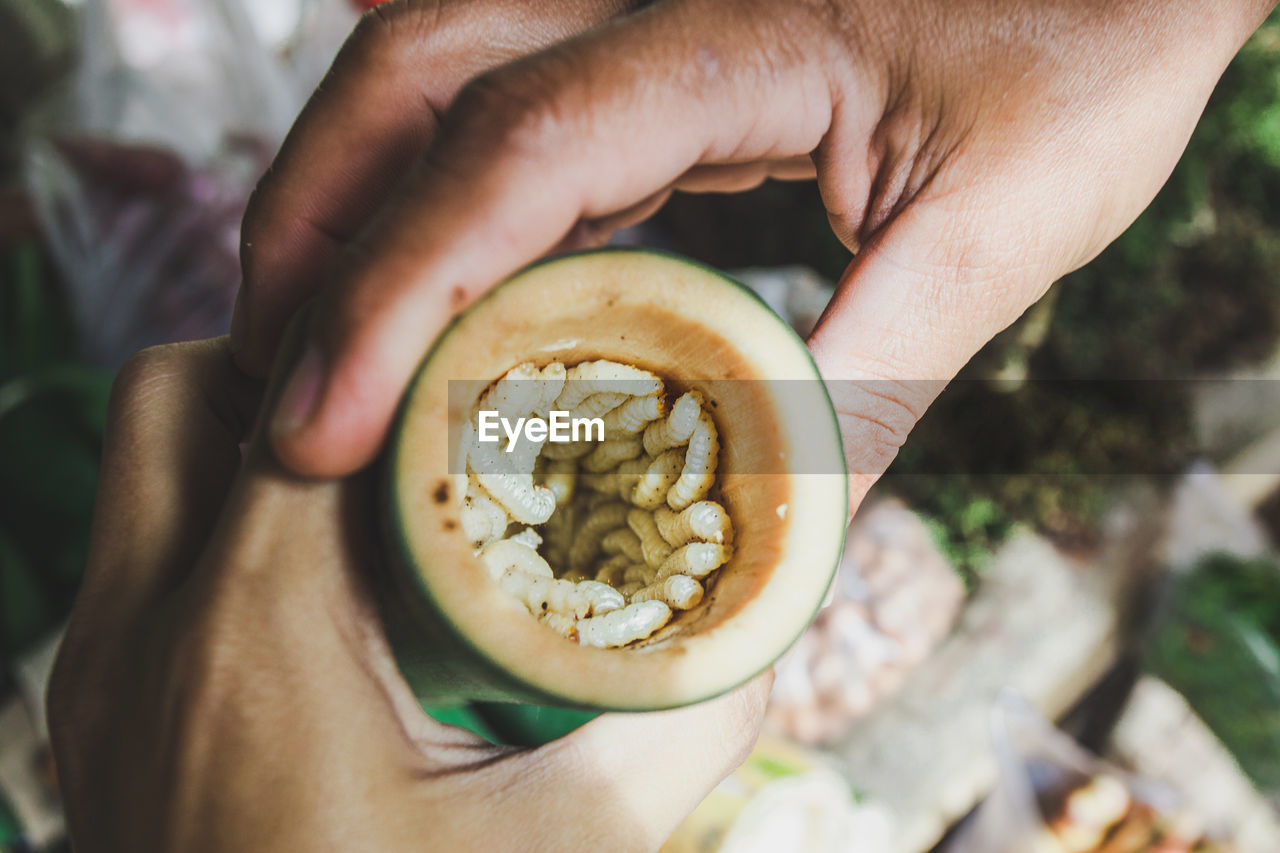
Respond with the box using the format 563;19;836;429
49;339;768;853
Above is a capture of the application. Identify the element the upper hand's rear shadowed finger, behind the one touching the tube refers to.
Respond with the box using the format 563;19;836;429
232;0;640;375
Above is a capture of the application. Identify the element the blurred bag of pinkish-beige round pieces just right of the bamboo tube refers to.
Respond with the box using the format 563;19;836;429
767;501;965;744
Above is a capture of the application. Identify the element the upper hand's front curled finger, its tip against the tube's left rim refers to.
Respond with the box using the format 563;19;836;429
273;3;860;475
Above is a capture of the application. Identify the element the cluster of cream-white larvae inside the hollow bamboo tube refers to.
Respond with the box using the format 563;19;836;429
458;360;733;647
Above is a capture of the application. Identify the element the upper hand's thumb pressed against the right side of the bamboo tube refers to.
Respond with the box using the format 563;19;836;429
808;200;1056;507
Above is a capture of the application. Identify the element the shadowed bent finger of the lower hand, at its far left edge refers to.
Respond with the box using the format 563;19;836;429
78;338;261;617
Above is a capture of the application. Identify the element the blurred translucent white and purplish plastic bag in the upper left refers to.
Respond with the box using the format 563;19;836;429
26;0;355;368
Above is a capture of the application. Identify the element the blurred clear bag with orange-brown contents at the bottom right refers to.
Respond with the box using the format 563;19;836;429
946;694;1230;853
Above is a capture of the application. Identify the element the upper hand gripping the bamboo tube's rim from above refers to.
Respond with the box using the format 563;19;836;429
233;0;1271;500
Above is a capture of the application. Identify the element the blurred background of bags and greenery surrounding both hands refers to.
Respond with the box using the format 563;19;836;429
0;0;1280;853
